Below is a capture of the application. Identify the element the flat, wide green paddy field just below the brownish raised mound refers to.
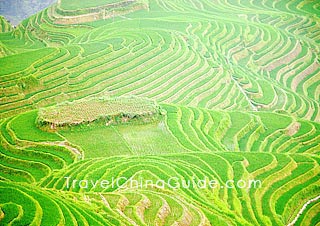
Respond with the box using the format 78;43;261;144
59;121;184;158
